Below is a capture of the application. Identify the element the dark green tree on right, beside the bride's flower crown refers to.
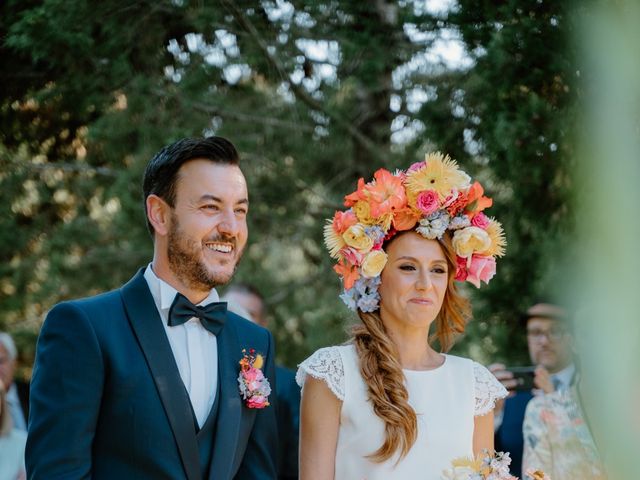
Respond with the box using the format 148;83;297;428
422;0;576;361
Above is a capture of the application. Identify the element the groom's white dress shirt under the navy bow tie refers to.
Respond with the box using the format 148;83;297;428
144;265;219;427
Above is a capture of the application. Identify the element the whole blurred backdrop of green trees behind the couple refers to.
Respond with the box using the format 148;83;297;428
0;0;573;372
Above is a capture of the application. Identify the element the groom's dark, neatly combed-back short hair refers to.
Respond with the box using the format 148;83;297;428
142;137;239;236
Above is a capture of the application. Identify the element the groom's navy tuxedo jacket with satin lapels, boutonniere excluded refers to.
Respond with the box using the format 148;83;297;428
26;269;277;480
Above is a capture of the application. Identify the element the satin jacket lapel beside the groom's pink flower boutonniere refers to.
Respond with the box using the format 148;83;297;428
209;319;243;480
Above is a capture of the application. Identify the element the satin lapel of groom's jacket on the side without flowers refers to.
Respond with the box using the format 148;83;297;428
120;269;202;480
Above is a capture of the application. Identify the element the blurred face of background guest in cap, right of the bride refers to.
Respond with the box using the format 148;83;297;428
527;317;573;373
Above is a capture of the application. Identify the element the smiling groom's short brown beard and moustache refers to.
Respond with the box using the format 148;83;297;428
167;213;243;291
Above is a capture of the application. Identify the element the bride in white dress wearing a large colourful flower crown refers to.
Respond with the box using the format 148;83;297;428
297;153;507;480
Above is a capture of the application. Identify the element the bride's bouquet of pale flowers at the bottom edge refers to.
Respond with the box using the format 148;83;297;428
441;450;551;480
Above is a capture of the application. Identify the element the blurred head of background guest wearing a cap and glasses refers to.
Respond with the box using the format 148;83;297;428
525;303;573;373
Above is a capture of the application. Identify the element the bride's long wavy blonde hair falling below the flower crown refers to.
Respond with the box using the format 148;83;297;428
352;232;471;462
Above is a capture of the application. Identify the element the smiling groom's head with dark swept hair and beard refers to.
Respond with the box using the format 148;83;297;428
143;137;249;293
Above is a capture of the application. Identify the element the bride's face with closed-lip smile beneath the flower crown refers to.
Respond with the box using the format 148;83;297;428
379;232;449;330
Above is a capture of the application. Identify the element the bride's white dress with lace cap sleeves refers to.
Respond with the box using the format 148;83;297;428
296;345;507;480
